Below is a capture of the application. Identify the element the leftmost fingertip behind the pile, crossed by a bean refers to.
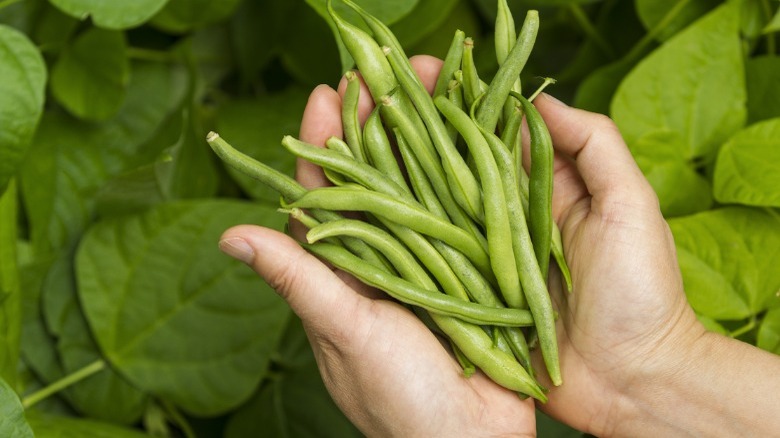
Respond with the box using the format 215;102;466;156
295;85;342;189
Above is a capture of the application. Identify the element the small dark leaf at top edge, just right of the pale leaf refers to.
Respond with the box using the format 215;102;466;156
151;0;241;33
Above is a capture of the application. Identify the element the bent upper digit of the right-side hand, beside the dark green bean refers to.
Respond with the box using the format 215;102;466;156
534;93;658;213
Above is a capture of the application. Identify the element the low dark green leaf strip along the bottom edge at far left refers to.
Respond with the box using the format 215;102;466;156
27;411;149;438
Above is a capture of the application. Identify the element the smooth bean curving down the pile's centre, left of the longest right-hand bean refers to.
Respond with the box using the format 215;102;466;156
436;96;524;307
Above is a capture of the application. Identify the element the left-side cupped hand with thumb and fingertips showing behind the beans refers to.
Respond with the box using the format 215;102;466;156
220;57;536;437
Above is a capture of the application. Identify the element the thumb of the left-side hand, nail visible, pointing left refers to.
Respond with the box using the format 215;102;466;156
219;225;368;331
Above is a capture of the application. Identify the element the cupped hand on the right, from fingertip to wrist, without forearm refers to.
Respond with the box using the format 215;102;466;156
534;94;705;436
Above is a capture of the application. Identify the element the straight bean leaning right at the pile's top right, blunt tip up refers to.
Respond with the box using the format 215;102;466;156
477;10;539;132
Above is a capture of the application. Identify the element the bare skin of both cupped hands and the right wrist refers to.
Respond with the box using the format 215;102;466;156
220;57;780;437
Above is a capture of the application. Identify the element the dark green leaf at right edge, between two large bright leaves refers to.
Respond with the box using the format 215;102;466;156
745;56;780;123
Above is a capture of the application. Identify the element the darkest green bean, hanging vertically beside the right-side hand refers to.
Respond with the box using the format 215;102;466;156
518;95;553;278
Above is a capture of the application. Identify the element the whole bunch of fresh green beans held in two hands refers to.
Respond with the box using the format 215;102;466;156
207;0;571;401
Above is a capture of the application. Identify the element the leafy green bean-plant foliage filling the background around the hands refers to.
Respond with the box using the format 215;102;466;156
0;0;780;437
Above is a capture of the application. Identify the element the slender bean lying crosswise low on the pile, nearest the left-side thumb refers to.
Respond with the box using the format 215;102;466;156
302;242;533;326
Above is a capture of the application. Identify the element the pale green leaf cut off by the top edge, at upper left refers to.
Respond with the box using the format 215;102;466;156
49;0;168;30
